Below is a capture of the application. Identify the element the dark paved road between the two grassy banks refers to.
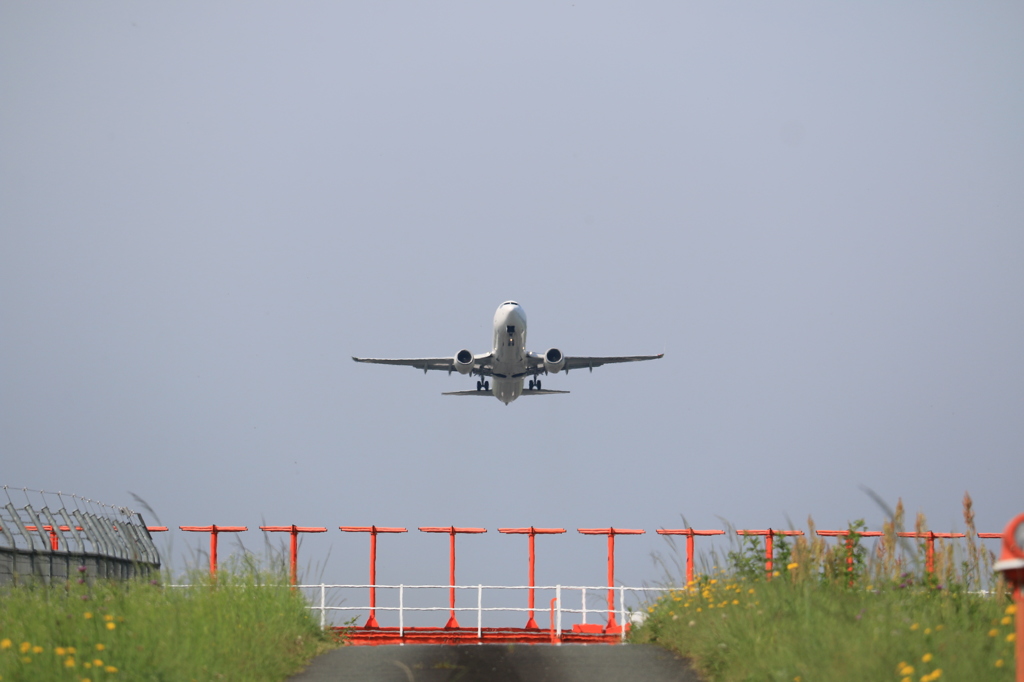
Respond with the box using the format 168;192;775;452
289;644;699;682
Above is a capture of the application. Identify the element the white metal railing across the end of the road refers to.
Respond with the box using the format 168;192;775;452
295;583;677;639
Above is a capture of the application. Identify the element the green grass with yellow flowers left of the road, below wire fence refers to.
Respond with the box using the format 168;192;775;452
0;566;334;682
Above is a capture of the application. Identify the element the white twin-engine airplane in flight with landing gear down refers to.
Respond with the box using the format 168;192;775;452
352;301;665;404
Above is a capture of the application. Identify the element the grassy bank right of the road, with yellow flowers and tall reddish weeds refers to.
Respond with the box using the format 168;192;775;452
631;493;1015;682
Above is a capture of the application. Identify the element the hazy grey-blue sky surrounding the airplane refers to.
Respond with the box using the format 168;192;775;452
0;1;1024;614
